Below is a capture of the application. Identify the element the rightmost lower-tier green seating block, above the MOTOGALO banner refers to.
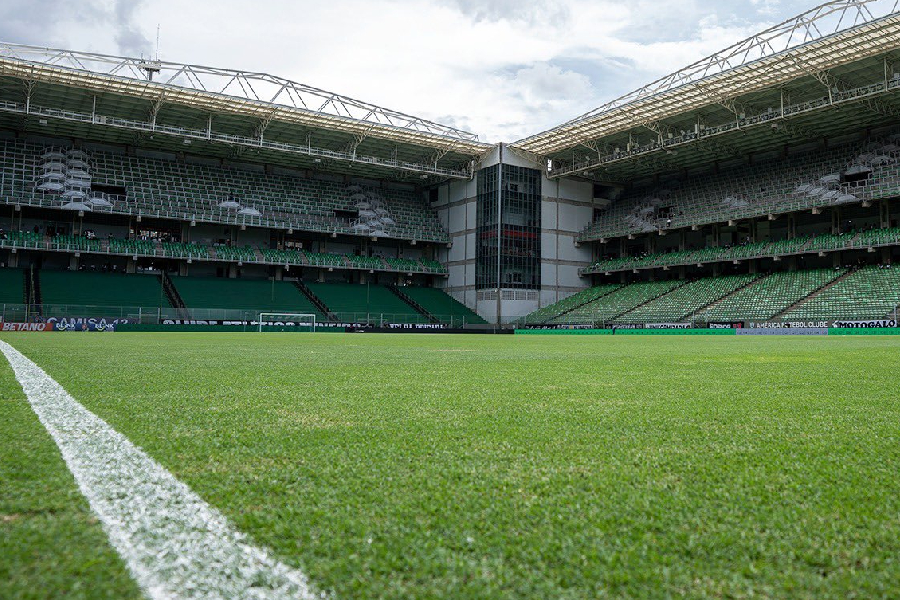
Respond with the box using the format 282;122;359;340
784;267;900;321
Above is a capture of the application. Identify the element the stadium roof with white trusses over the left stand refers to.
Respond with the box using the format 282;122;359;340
0;43;492;179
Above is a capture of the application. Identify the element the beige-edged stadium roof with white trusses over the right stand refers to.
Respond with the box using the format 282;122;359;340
513;0;900;180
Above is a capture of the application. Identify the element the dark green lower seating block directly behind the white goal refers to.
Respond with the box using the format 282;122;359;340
172;277;325;320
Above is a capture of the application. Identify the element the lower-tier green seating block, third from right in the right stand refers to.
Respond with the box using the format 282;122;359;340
616;275;757;323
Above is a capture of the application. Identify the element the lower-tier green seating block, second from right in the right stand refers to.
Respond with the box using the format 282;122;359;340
697;269;844;321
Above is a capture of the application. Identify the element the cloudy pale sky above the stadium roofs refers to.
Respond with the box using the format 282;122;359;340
0;0;817;142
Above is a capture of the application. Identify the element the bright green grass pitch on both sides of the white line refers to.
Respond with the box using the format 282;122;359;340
0;333;900;599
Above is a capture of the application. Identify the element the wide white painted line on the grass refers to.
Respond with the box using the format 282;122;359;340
0;341;318;600
